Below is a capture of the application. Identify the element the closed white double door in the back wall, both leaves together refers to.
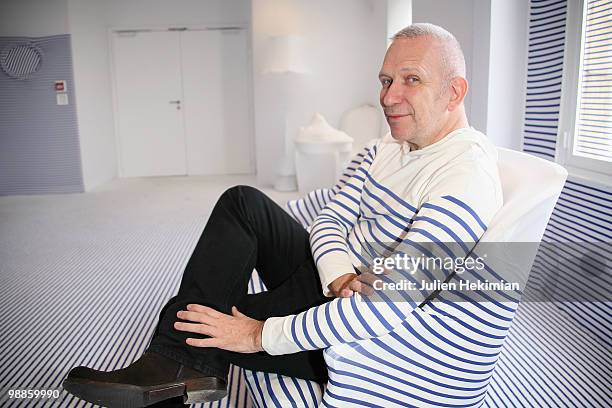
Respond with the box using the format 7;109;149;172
112;28;254;177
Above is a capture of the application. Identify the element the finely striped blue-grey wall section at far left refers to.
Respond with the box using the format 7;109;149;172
0;34;83;195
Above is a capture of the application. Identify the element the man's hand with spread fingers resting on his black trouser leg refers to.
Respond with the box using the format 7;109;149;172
174;305;264;353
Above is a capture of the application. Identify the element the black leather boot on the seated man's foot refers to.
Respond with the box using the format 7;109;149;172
62;352;227;408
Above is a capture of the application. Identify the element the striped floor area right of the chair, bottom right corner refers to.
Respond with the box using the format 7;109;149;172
485;302;612;407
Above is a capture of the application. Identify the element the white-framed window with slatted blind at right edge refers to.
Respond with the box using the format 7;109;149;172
557;0;612;184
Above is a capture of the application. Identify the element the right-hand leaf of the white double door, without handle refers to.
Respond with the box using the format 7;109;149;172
181;29;255;174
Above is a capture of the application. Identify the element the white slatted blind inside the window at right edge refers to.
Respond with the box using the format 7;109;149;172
573;0;612;161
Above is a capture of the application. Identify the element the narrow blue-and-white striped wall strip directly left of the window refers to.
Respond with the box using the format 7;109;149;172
523;0;566;160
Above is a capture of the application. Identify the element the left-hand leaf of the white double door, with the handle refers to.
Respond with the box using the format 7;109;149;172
113;31;187;177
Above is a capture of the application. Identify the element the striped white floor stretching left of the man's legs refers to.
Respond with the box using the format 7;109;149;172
0;176;297;406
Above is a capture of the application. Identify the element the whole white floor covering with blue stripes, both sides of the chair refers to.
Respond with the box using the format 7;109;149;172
0;178;612;408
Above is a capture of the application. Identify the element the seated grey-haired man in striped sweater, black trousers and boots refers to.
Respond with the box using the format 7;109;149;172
64;24;502;406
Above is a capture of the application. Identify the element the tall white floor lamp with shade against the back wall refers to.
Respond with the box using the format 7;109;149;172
264;35;306;191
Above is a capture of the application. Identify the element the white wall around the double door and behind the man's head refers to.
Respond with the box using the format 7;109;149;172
0;0;528;190
